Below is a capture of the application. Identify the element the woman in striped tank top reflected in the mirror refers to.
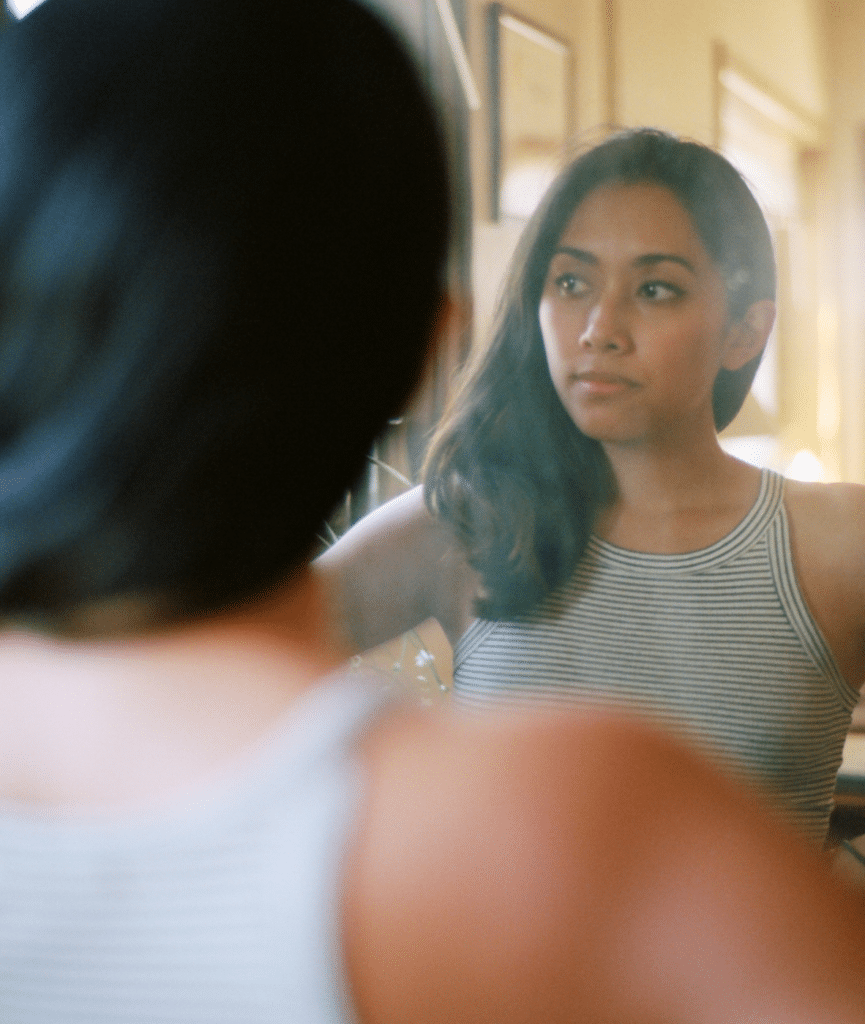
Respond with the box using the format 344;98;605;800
320;129;865;840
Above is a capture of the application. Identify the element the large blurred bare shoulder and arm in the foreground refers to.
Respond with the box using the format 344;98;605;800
343;714;865;1024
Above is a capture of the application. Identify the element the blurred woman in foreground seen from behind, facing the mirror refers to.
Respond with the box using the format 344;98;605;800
0;0;865;1024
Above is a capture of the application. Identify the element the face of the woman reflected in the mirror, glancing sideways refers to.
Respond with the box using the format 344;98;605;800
538;183;736;443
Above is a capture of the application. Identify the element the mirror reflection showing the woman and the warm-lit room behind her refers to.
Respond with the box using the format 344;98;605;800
335;0;865;864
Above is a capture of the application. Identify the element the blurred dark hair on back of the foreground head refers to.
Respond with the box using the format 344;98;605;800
0;0;449;629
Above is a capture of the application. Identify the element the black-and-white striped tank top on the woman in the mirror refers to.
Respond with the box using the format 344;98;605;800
453;470;858;842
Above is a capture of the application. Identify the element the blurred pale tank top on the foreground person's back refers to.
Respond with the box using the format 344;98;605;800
0;676;383;1024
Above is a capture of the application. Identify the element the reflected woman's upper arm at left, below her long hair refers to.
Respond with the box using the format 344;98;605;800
313;487;462;652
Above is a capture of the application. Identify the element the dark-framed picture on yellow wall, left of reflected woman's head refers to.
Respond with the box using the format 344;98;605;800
488;3;572;220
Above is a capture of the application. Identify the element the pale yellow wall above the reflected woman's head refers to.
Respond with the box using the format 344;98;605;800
468;0;827;201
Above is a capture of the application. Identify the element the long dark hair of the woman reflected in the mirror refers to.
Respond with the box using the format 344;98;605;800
424;128;775;618
